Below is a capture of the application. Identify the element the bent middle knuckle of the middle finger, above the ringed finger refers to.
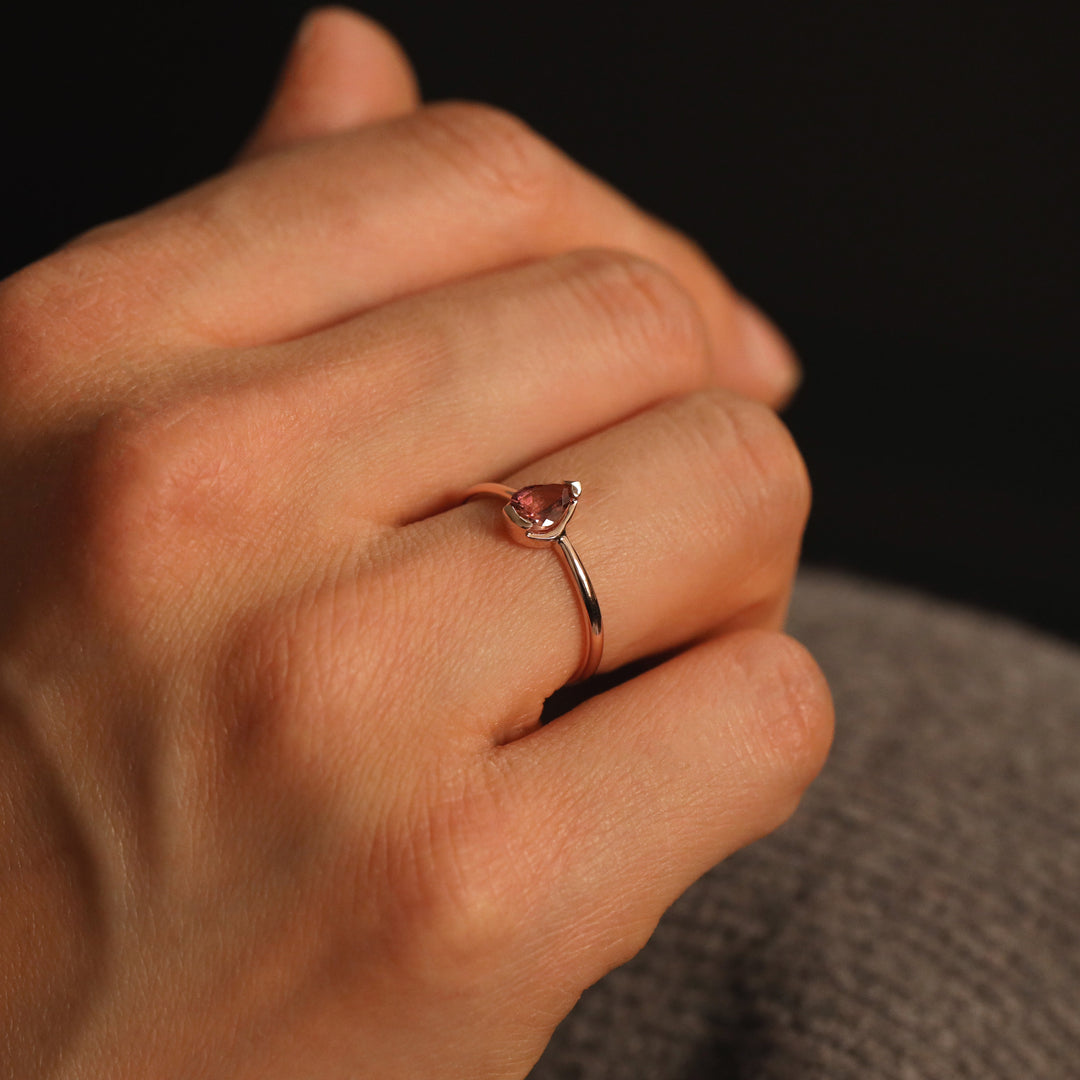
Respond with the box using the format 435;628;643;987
567;248;707;389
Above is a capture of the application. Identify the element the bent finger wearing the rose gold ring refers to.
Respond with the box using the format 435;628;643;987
349;390;809;740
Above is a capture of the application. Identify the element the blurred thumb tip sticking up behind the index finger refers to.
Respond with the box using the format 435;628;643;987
239;8;419;160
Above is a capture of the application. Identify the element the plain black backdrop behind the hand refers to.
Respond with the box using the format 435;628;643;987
0;0;1080;639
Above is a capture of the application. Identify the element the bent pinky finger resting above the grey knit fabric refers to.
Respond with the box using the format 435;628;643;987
502;631;833;988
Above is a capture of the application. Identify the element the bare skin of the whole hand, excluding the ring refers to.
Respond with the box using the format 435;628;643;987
0;9;832;1080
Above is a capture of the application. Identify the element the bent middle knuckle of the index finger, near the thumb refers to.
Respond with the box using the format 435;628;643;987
416;102;559;216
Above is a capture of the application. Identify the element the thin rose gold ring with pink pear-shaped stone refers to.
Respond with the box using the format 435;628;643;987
464;481;604;683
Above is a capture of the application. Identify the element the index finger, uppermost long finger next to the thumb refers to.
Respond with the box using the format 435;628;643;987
45;104;796;403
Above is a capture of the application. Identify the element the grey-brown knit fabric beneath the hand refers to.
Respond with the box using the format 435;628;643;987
531;572;1080;1080
